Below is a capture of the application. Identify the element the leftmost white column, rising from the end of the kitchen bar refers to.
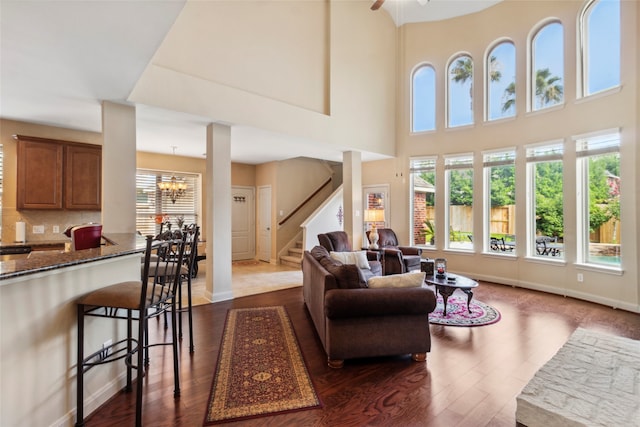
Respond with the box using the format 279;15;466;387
102;101;136;234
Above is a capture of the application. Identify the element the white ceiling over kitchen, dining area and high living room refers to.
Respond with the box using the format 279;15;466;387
0;0;500;164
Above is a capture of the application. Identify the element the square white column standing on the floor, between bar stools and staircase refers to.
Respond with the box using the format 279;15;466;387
205;123;233;302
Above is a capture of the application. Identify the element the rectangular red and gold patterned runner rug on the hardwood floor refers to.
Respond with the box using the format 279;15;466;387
204;306;321;425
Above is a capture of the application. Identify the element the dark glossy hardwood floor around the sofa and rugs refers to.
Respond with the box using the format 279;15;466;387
87;282;640;427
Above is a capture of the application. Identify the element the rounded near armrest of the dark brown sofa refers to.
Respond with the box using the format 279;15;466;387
324;287;436;319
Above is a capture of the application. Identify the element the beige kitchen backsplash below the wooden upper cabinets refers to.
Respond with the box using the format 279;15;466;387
2;209;102;244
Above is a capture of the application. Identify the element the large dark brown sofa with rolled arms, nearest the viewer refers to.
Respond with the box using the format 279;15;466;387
302;246;436;368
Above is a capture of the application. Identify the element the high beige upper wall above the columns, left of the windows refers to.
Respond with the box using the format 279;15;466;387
130;0;397;159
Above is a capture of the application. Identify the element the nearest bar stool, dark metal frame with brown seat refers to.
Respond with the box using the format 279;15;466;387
76;236;184;427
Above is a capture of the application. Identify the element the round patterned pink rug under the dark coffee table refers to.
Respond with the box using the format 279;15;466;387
429;291;500;326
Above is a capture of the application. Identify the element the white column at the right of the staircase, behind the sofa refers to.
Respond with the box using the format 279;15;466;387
342;151;363;250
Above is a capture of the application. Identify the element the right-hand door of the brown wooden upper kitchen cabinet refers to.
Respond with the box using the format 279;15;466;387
64;145;102;210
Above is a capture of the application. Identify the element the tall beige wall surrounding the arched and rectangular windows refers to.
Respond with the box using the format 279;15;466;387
363;1;640;311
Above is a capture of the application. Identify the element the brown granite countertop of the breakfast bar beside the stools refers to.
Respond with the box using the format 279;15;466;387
0;233;146;281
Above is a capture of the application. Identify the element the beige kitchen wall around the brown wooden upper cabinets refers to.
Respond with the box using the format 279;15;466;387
0;119;102;243
